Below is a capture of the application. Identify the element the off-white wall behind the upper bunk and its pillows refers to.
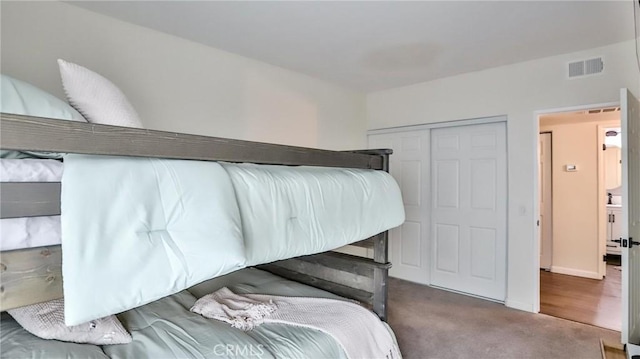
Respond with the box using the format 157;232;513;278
1;1;366;149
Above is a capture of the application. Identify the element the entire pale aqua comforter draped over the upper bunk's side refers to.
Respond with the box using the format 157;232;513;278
61;155;404;325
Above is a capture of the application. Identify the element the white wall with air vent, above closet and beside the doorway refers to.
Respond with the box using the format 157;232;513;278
367;41;640;311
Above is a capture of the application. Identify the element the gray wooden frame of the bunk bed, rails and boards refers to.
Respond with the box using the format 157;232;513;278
0;113;392;320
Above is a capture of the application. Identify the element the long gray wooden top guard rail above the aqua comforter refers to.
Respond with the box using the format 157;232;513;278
0;113;383;170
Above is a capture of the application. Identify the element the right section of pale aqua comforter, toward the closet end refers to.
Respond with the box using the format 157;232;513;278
222;163;404;266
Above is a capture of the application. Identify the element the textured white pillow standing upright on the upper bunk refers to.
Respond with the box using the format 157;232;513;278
58;59;142;128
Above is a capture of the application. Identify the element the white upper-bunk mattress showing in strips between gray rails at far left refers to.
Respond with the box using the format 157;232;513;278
0;159;63;251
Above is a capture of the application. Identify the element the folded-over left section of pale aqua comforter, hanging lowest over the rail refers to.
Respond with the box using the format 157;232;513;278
61;155;245;325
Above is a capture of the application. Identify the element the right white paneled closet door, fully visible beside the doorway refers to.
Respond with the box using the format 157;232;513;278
431;122;507;301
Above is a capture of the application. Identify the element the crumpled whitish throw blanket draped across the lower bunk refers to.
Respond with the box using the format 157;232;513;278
191;287;402;359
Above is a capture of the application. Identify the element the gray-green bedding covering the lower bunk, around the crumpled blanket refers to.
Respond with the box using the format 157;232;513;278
0;268;395;359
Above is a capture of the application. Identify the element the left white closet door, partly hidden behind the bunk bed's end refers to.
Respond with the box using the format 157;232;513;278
369;130;429;284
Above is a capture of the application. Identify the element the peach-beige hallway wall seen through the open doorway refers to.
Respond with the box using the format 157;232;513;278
540;112;620;279
